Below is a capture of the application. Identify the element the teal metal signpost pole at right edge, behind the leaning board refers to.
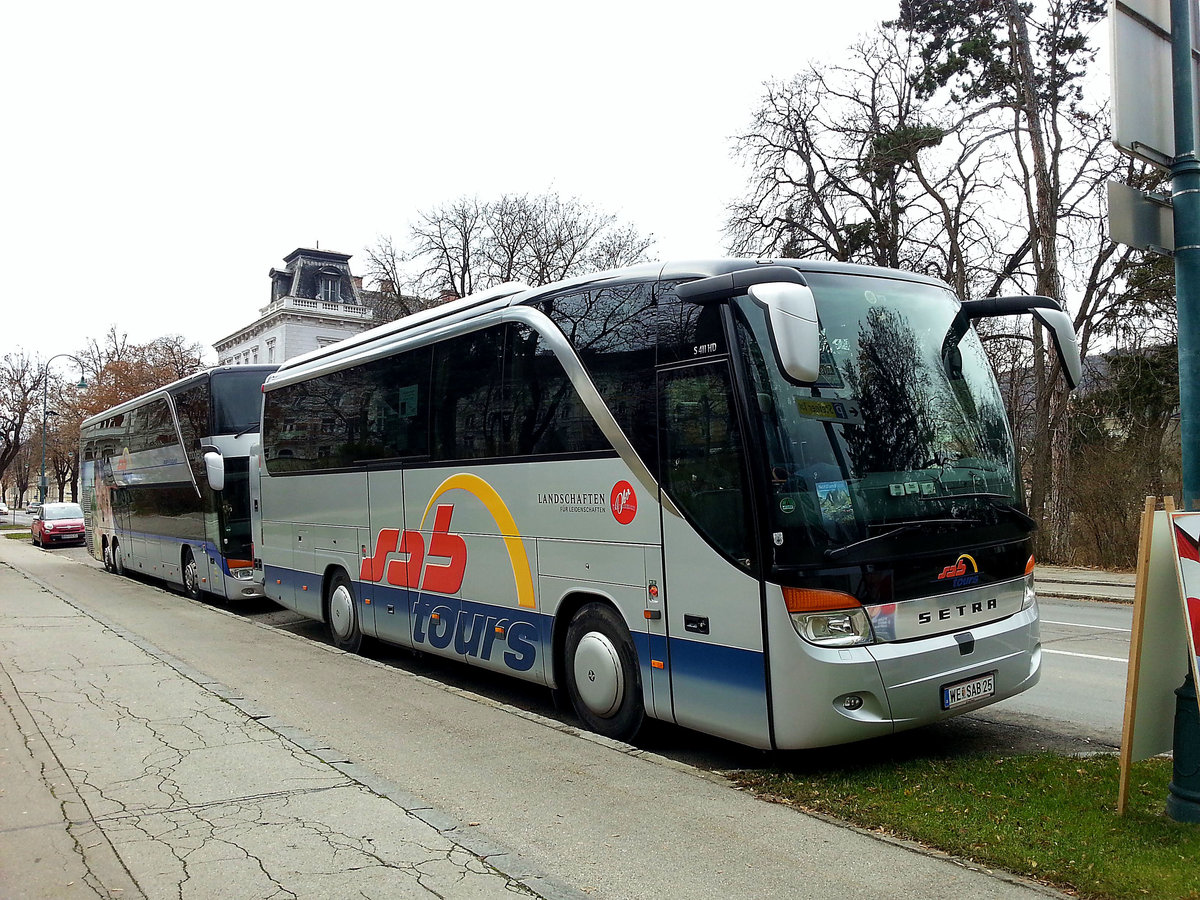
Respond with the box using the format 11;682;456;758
1166;0;1200;822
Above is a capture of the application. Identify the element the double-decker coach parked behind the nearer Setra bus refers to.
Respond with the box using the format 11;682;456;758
79;366;275;600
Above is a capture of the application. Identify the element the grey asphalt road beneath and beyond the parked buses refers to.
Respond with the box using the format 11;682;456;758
28;535;1132;772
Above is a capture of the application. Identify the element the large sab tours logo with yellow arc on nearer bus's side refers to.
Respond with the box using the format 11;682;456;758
359;473;538;672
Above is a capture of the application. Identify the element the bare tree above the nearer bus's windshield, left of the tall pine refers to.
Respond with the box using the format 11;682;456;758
727;26;1001;296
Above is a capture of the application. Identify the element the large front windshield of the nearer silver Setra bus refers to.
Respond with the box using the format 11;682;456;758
733;272;1033;569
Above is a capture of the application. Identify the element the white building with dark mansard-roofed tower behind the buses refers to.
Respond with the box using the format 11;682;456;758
212;247;374;366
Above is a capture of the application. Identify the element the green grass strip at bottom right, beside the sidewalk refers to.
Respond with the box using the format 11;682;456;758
731;754;1200;900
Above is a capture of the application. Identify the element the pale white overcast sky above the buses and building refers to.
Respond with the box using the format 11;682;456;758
0;0;896;367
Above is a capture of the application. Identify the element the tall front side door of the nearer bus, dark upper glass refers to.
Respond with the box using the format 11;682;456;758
658;356;769;745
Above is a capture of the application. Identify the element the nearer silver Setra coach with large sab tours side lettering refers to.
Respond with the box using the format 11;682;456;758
256;259;1079;749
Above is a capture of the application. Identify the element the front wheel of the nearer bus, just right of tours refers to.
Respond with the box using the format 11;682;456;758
566;604;646;740
